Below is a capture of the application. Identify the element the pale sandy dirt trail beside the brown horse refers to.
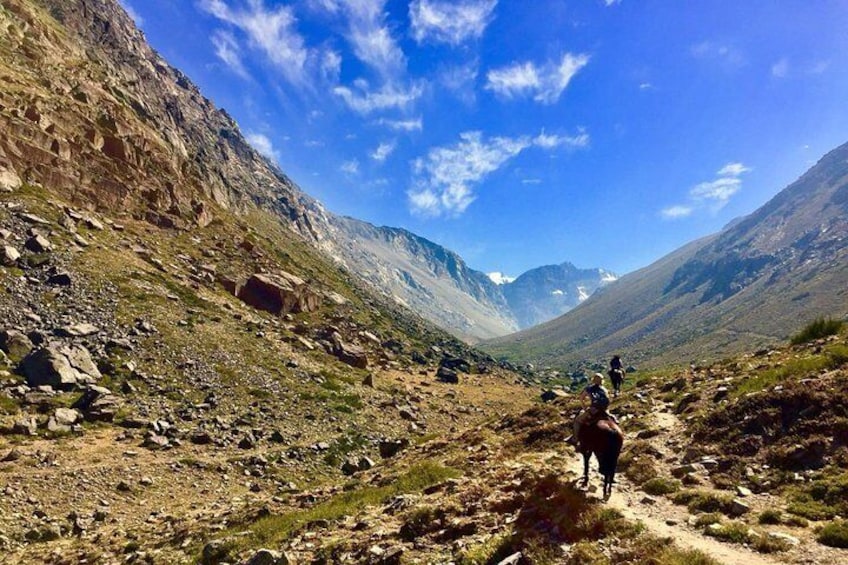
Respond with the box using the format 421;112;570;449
570;411;785;565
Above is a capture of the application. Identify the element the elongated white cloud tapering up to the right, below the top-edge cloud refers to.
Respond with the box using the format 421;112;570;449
485;53;589;104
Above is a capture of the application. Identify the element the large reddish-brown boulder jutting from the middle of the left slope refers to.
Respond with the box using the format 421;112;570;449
236;271;321;315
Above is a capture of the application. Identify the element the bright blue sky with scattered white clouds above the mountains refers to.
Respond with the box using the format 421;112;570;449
122;0;848;276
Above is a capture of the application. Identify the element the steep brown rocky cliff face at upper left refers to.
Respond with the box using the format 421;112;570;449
0;0;322;239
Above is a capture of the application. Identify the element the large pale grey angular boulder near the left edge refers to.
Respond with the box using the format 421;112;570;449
21;345;101;390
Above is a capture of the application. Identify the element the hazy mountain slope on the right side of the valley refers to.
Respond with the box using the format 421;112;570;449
486;145;848;365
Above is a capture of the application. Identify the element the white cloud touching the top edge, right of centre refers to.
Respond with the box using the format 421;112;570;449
409;0;498;45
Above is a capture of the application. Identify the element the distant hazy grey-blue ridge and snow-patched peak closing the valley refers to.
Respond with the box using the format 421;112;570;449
322;216;615;343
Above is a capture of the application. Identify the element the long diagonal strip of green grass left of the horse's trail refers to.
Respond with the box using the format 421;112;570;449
215;462;461;549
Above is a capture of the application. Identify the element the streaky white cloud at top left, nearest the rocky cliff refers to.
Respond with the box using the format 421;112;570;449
199;0;315;85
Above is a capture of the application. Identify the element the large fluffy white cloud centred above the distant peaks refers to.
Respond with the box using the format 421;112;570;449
407;131;532;216
